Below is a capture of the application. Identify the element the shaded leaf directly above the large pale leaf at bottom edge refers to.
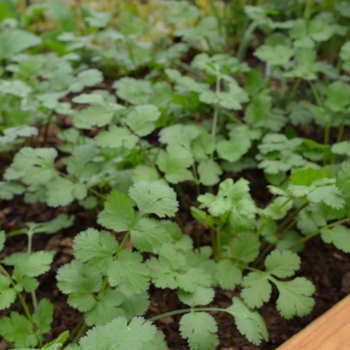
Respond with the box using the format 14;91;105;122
85;289;125;326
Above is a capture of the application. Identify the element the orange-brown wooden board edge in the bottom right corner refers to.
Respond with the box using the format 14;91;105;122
276;295;350;350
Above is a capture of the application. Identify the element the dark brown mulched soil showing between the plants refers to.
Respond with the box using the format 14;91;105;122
0;82;350;350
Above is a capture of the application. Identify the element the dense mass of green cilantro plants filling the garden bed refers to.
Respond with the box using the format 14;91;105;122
0;0;350;350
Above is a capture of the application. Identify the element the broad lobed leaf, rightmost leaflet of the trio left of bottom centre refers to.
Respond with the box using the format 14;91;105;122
107;249;150;295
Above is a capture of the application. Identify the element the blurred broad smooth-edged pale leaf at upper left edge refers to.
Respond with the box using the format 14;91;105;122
0;29;41;58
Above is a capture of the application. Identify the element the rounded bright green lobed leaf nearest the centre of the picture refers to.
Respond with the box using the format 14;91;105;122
157;145;193;183
